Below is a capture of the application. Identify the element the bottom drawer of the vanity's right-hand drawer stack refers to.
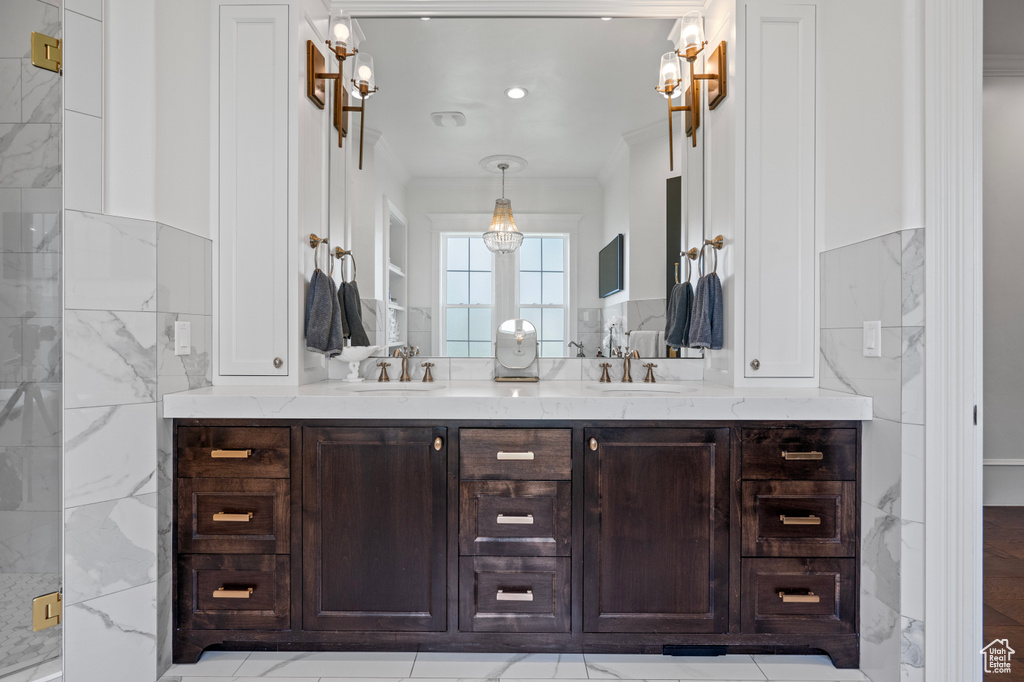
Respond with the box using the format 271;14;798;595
741;559;857;635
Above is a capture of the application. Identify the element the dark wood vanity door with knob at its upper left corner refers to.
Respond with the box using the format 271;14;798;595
583;428;729;633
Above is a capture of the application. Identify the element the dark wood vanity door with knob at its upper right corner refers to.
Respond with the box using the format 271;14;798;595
302;427;447;632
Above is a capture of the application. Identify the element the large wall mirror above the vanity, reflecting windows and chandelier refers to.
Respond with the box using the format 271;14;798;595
331;16;707;357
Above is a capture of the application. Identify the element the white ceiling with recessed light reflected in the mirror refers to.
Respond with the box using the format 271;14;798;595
353;18;678;178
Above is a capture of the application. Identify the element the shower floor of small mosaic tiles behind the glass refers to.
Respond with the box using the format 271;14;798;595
0;573;60;681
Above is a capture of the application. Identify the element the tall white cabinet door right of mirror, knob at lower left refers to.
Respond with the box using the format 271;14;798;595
744;2;817;378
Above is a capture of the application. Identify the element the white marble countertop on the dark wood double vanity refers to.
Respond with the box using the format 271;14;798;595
164;381;871;421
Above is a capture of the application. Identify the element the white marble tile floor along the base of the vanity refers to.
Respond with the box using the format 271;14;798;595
160;651;867;682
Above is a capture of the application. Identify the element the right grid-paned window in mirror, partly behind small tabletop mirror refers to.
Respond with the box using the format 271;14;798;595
519;236;568;357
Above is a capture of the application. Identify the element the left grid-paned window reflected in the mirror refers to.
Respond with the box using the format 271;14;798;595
443;236;495;357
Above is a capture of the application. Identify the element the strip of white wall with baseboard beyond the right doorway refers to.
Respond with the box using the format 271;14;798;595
983;77;1024;504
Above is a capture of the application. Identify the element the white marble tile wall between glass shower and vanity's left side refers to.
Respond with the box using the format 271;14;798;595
63;210;212;682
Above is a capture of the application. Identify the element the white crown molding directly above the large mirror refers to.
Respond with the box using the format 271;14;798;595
331;0;705;18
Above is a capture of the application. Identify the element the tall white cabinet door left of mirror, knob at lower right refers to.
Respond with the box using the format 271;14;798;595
218;5;293;375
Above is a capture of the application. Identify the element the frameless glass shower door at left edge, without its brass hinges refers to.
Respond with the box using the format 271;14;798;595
0;0;62;677
